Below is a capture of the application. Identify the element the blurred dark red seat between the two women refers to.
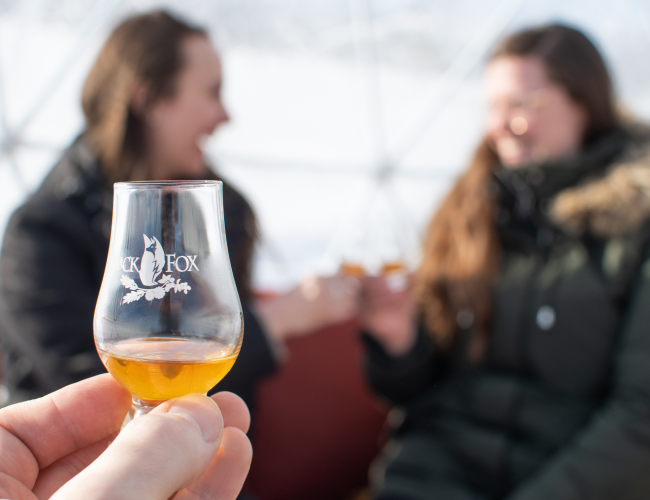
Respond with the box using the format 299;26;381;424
247;322;386;500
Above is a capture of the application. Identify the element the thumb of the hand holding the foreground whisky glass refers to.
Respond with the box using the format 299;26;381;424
52;394;223;500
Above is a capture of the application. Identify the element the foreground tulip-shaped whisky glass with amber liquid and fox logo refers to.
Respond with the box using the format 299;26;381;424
94;181;244;418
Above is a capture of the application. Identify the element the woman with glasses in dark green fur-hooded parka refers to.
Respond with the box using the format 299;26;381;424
362;25;650;500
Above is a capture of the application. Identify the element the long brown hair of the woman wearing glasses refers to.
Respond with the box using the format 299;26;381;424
415;24;617;357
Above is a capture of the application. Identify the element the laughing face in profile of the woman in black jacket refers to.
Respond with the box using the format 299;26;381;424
145;35;229;180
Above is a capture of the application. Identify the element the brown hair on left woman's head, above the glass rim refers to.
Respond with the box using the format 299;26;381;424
81;10;208;182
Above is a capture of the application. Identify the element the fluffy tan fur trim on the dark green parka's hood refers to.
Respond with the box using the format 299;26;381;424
549;147;650;238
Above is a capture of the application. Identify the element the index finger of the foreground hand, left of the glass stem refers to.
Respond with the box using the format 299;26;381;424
0;374;131;474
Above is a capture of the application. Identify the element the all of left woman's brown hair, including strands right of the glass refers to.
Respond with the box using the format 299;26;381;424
81;10;258;302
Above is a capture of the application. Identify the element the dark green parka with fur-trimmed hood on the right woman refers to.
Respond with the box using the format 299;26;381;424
366;129;650;500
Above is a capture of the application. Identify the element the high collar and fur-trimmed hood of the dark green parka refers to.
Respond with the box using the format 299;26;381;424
494;127;650;238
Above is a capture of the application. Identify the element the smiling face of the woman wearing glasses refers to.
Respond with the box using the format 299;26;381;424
486;56;587;168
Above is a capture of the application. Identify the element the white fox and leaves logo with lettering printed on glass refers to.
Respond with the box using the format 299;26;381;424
120;234;199;304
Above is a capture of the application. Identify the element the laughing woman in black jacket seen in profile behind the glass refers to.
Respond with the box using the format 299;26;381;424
0;11;356;405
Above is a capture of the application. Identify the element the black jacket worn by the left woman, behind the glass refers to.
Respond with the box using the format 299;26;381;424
0;137;275;405
